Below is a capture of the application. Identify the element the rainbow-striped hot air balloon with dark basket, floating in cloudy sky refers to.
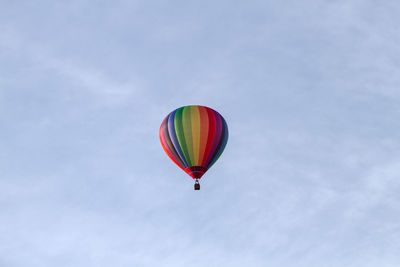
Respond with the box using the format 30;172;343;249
160;105;228;190
